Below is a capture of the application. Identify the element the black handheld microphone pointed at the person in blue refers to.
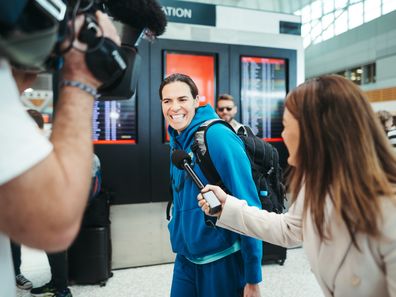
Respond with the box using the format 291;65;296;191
172;150;221;214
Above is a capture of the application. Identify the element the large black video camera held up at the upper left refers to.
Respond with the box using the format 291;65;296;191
0;0;166;100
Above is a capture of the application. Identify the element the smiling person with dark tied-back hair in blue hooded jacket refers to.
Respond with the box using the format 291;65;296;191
159;73;262;297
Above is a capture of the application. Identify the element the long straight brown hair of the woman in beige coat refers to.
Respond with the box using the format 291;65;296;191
285;75;396;246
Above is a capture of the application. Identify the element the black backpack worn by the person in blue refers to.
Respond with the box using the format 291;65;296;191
191;119;286;213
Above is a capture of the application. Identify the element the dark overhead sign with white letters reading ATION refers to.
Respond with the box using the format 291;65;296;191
160;0;216;26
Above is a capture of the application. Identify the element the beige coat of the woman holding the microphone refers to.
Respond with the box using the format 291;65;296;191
217;187;396;297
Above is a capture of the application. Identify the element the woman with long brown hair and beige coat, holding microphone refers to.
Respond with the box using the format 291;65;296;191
198;75;396;297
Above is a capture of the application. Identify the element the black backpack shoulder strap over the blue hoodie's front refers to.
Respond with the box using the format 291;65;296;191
191;119;235;192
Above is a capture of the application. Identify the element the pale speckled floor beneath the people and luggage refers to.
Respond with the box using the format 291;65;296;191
17;247;323;297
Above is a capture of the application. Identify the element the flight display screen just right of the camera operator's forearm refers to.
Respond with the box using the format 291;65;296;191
92;96;137;144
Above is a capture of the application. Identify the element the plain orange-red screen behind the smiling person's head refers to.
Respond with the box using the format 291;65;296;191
163;51;217;142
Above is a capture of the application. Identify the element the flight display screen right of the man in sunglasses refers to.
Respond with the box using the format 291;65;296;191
241;56;287;142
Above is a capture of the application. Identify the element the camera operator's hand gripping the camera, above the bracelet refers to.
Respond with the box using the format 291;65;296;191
62;11;121;89
